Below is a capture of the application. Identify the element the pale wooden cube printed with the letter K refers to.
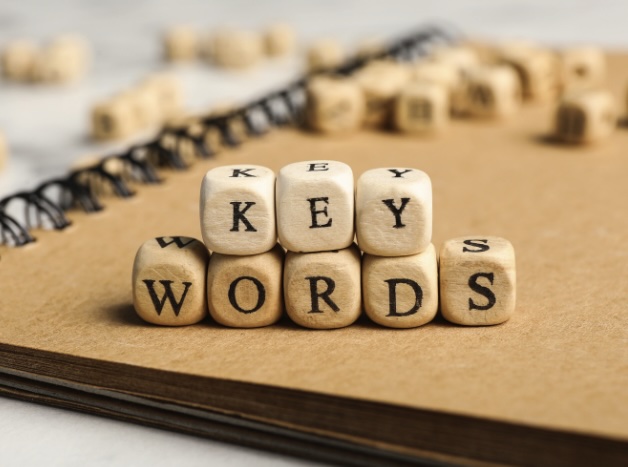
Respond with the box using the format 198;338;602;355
200;165;277;255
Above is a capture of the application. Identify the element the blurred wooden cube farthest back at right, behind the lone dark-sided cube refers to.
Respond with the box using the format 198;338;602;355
561;47;606;91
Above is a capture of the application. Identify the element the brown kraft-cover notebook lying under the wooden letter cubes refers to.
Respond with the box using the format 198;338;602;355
0;32;628;465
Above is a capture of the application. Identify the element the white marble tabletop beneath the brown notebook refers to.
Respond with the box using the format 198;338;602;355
0;0;628;466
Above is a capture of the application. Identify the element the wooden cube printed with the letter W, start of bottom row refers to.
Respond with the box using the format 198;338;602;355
133;237;209;326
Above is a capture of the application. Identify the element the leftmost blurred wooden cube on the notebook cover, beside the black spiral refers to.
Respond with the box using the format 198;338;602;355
307;77;364;134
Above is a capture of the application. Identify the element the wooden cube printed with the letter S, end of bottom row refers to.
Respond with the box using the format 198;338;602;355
440;236;516;326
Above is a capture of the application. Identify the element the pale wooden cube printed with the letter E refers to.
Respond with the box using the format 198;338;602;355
276;161;355;252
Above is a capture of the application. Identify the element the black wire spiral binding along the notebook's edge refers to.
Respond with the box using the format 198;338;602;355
0;26;457;246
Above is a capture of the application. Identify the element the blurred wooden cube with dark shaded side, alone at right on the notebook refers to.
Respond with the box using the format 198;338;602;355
555;91;617;143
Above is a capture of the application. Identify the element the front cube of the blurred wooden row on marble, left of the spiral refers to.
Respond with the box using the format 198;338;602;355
91;96;138;140
